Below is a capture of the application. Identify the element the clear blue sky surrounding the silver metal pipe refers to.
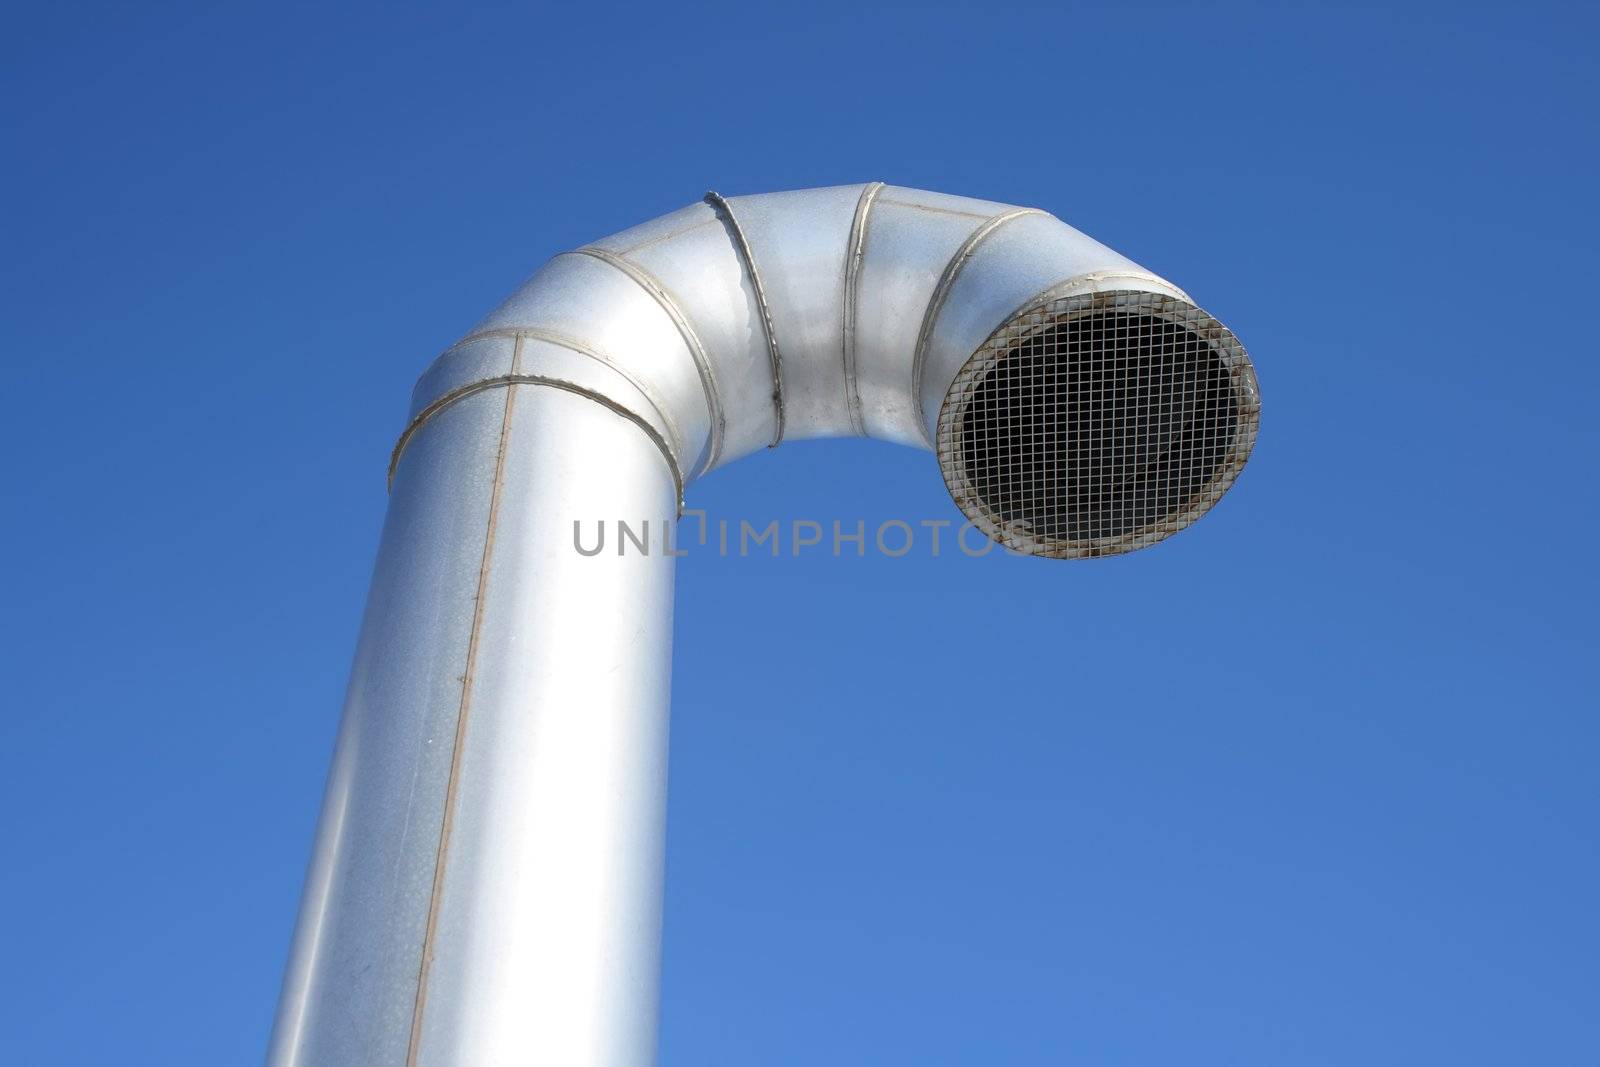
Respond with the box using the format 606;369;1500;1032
0;3;1600;1067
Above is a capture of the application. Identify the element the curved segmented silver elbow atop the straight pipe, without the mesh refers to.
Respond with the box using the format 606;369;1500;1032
395;182;1254;553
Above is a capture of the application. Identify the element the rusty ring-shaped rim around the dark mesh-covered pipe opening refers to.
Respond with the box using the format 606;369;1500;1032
936;290;1261;560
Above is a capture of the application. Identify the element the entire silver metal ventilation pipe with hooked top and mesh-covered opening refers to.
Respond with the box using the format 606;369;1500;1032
269;182;1259;1067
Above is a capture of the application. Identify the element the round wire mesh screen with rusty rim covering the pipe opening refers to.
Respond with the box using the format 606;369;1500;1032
938;291;1261;558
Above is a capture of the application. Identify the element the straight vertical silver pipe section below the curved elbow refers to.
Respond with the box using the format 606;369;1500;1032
269;384;677;1067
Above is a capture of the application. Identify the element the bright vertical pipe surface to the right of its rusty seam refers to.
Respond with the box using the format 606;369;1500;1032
413;386;677;1067
